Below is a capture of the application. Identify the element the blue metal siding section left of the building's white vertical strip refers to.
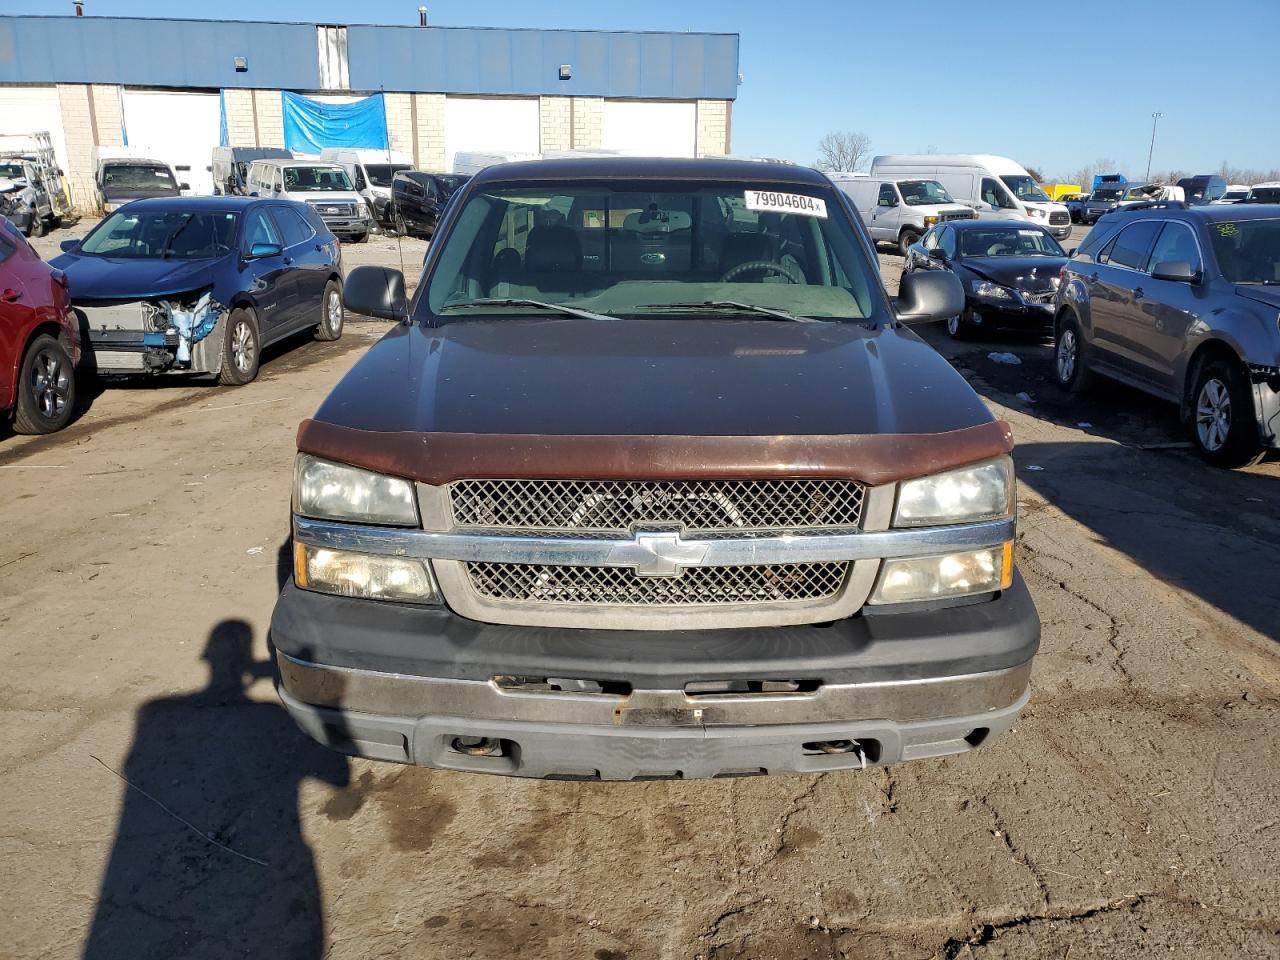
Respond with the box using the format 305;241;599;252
0;17;320;90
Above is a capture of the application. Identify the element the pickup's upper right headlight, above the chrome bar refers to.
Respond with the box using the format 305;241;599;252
893;457;1014;526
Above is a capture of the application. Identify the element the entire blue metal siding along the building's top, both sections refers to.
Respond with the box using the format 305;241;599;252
0;17;737;100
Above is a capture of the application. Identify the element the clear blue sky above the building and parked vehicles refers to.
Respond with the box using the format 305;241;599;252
10;0;1280;177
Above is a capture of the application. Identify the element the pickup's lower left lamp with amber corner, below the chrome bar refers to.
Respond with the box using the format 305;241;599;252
293;543;440;603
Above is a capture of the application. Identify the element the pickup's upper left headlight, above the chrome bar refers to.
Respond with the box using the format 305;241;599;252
293;453;419;526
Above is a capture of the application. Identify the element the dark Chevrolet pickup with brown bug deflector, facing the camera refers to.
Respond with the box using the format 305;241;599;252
271;159;1039;780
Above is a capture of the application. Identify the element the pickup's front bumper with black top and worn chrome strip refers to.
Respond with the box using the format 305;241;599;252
271;570;1039;780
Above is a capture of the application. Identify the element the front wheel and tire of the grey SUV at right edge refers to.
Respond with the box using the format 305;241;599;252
1190;360;1266;470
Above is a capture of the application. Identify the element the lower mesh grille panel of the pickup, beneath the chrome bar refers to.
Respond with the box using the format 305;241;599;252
466;562;850;607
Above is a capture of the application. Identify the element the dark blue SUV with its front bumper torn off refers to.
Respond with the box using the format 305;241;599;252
52;197;343;385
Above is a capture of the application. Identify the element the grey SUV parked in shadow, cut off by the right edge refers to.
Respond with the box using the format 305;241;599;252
1055;204;1280;467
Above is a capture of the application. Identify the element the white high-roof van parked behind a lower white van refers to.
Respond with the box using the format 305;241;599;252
870;154;1071;239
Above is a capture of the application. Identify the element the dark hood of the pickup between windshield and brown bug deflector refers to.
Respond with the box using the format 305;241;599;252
314;316;993;436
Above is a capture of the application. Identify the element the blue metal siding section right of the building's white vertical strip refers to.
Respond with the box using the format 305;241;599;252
347;27;737;100
